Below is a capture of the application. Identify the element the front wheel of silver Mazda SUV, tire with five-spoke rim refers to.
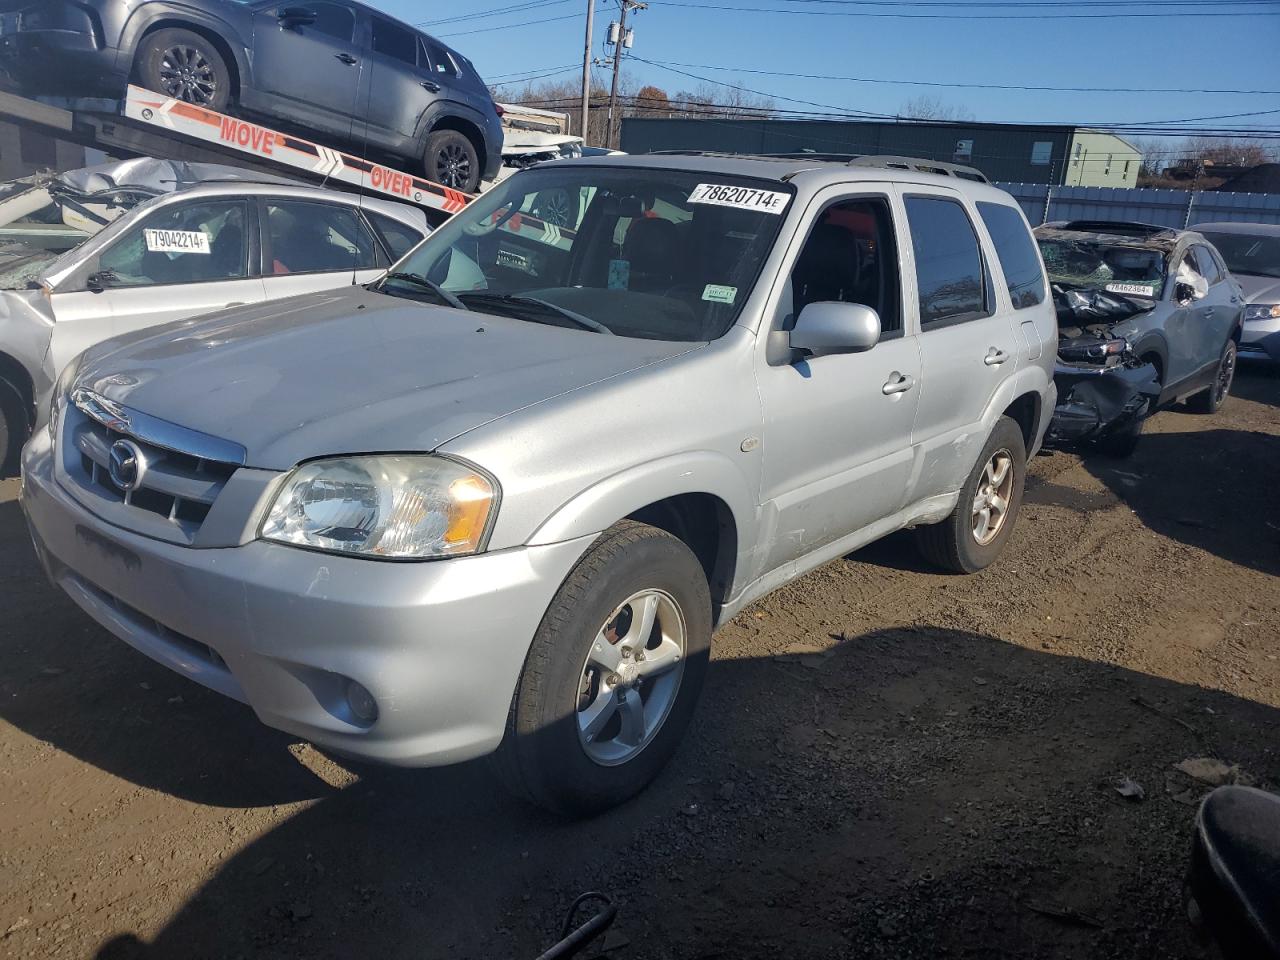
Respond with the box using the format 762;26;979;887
493;521;712;817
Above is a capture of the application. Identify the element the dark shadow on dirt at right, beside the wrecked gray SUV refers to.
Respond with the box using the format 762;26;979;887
1075;430;1280;575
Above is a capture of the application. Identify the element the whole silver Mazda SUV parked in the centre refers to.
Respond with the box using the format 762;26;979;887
23;156;1056;813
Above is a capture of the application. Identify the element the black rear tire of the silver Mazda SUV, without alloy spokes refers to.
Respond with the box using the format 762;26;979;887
916;417;1027;573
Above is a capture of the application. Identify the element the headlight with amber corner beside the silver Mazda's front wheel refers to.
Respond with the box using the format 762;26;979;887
261;456;498;559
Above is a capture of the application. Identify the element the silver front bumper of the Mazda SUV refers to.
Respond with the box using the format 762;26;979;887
22;431;591;765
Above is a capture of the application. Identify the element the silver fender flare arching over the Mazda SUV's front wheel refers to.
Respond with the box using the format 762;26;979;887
526;451;756;555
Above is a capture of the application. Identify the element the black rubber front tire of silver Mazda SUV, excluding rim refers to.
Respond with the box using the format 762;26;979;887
493;521;712;817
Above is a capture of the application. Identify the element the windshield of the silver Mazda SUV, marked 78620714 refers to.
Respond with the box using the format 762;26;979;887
379;163;794;342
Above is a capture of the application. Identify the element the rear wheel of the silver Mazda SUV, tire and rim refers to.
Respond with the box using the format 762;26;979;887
916;417;1027;573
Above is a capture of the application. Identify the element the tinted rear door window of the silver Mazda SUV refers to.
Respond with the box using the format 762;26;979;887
905;196;989;330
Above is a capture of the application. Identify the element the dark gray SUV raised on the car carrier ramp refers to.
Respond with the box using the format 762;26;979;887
0;0;503;192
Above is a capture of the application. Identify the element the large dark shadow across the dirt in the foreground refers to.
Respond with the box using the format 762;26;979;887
85;627;1280;960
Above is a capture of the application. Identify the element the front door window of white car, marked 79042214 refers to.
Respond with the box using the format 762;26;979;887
97;200;248;287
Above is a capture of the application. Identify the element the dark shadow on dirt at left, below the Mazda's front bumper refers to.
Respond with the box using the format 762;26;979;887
0;500;329;806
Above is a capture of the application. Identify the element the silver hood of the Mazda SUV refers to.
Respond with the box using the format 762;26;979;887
77;287;701;470
